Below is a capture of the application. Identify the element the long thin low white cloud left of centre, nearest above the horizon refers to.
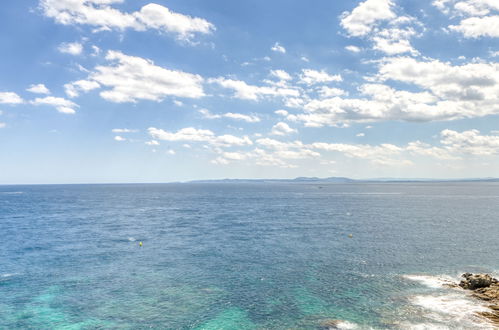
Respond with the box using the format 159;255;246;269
148;127;253;147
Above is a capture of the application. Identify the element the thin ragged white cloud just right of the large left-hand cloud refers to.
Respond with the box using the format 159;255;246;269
210;78;300;101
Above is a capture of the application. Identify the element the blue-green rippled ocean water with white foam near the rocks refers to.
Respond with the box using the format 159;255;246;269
0;183;499;330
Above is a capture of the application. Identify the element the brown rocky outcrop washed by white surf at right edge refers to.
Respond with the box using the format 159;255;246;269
459;273;499;325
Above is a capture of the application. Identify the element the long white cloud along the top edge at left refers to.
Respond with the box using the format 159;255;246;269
40;0;215;40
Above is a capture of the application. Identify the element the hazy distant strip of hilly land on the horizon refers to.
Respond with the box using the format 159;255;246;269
188;177;499;183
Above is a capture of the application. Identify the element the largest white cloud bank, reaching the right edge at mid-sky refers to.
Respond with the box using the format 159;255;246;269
286;57;499;127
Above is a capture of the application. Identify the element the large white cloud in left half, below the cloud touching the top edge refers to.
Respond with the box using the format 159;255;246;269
83;51;205;103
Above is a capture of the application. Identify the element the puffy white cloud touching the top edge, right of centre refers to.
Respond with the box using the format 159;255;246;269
341;0;396;37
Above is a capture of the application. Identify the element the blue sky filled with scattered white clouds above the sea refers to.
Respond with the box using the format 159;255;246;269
0;0;499;184
